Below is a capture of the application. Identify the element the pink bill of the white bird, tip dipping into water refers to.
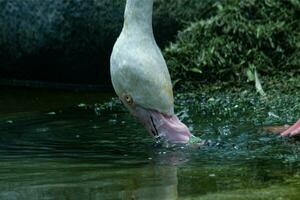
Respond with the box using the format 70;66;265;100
134;108;192;144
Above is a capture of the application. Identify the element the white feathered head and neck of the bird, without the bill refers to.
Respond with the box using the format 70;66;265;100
110;0;174;115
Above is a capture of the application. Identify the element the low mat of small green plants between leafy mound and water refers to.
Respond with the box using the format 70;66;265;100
175;75;300;125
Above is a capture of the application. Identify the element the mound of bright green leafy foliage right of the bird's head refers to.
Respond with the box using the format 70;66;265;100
164;0;300;87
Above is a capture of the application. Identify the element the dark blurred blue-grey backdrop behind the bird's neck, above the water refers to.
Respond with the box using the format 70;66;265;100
0;0;185;87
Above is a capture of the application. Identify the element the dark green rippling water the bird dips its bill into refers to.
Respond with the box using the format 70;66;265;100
0;88;300;200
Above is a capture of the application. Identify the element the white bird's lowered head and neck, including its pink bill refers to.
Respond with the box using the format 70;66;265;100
110;0;196;144
